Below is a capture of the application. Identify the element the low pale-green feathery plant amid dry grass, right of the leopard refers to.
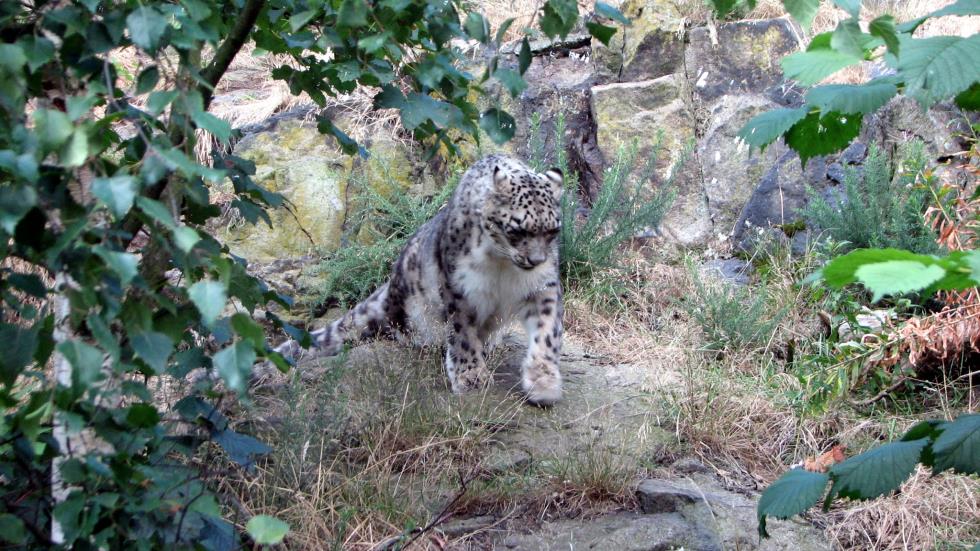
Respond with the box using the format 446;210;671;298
680;265;788;351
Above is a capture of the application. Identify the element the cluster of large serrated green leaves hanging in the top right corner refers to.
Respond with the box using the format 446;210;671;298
736;0;980;165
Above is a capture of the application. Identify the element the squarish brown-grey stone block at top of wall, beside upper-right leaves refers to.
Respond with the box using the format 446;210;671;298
684;18;802;105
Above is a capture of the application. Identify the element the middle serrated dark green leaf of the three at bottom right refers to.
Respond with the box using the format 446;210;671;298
825;438;929;503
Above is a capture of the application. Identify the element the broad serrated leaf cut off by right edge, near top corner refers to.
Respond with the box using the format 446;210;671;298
897;33;980;107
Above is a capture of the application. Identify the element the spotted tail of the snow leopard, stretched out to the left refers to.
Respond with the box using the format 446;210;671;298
276;283;389;359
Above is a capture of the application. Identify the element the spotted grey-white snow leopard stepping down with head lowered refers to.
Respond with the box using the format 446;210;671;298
276;155;563;406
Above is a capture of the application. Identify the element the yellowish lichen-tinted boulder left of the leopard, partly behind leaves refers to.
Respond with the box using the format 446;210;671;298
218;119;351;262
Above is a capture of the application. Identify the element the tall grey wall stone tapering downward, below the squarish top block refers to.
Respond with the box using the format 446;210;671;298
697;94;780;242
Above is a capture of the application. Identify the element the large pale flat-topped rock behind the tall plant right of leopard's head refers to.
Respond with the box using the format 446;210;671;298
592;75;712;244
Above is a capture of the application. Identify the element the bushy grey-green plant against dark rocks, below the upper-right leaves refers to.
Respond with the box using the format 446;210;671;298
802;141;939;253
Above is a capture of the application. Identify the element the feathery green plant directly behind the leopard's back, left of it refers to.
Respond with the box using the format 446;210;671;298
315;177;456;306
